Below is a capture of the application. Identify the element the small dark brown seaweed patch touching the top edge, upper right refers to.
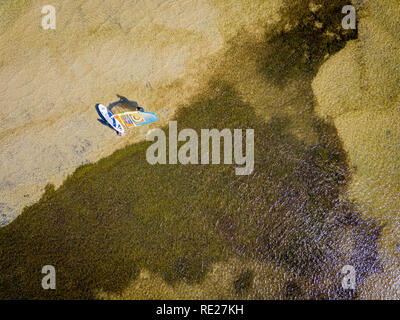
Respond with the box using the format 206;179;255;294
258;0;357;87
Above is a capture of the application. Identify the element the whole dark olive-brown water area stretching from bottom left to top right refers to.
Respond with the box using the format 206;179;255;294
0;1;396;299
